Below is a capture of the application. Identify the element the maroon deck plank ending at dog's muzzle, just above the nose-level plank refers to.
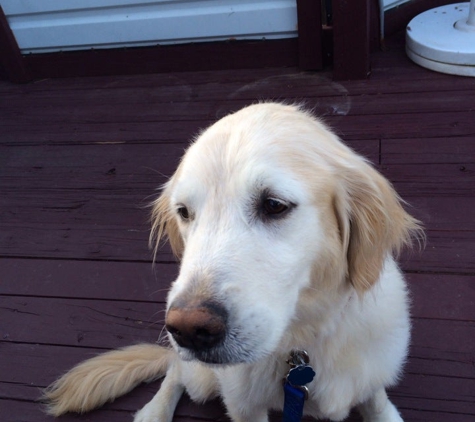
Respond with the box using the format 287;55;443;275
0;258;178;303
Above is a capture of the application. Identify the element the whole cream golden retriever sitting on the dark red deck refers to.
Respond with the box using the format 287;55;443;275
45;103;420;422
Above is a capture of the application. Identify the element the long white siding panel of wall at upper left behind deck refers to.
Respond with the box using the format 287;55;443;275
0;0;297;54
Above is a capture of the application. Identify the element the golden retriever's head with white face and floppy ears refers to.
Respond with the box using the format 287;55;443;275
151;103;418;363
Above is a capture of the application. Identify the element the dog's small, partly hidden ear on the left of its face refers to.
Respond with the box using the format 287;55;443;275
149;188;184;259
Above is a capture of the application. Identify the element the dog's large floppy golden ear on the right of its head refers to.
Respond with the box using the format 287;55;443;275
335;160;422;292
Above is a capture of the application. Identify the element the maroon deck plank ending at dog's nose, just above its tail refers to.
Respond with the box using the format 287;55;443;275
0;296;165;348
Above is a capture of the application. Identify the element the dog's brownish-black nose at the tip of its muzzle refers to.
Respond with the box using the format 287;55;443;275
165;302;228;351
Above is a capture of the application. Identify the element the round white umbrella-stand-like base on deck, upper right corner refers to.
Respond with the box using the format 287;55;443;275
406;0;475;77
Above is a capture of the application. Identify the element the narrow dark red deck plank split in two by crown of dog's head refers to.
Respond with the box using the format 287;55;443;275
1;111;475;145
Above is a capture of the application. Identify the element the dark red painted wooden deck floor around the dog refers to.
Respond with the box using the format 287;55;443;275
0;33;475;422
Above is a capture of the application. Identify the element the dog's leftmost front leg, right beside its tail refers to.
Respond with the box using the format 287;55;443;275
134;365;185;422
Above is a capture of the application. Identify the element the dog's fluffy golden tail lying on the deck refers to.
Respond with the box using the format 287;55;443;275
43;344;176;416
